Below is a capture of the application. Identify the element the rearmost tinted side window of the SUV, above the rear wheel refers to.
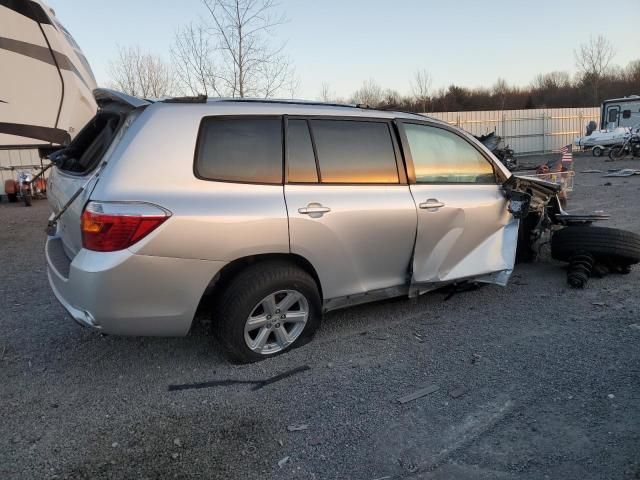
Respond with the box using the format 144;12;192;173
196;117;282;183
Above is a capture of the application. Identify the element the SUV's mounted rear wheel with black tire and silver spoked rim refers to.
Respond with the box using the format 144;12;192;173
213;260;322;363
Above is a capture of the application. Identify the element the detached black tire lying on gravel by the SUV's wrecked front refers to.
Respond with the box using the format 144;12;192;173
551;226;640;266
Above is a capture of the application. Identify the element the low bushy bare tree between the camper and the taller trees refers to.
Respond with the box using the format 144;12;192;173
108;46;176;98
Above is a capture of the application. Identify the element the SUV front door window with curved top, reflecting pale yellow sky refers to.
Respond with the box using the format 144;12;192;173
404;124;496;184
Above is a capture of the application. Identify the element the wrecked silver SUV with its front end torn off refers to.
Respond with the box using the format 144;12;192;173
46;90;553;362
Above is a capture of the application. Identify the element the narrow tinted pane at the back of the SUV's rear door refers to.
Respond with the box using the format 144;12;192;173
287;120;318;183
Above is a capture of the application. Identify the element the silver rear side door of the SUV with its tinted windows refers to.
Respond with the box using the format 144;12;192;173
285;117;416;299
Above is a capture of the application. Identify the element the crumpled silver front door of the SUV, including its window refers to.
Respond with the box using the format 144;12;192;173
400;122;518;286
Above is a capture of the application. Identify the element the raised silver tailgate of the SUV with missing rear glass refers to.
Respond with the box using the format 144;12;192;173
47;90;149;258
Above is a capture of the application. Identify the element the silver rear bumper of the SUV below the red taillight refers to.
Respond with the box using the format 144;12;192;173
45;237;225;336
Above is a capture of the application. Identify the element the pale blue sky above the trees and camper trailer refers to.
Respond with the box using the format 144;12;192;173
45;0;640;98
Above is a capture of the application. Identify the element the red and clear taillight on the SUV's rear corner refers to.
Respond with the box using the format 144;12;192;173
81;202;171;252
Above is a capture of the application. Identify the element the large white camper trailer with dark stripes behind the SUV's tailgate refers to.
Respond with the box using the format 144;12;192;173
0;0;97;150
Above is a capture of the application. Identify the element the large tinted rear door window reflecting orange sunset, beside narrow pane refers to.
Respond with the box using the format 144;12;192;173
310;120;398;183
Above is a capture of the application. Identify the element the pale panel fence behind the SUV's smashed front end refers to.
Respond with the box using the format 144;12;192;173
425;107;600;155
